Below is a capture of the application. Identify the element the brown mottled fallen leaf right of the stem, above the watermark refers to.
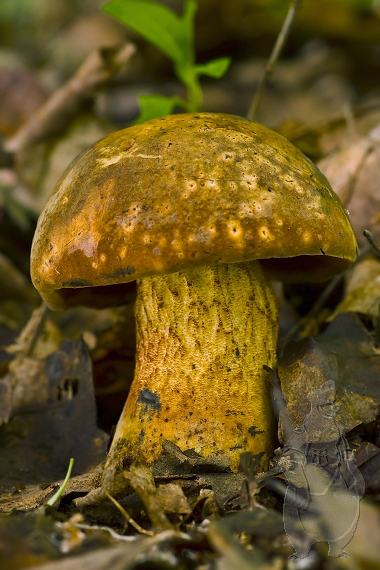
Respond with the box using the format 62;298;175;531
278;313;380;435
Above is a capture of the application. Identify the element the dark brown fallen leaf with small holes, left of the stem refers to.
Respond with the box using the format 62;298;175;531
0;339;108;489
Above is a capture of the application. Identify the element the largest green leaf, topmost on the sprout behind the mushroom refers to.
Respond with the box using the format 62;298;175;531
102;0;197;65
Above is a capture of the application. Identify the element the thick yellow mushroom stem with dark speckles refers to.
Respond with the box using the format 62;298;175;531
106;261;278;472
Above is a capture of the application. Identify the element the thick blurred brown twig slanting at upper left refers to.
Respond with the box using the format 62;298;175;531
4;43;136;154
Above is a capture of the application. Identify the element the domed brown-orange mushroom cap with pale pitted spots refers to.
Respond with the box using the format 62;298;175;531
31;113;357;309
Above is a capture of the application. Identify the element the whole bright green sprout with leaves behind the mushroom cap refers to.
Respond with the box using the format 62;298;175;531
102;0;231;124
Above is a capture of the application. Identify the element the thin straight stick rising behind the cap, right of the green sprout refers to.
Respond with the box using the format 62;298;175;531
247;0;301;121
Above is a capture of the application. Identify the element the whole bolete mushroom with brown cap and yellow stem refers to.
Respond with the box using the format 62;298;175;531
31;113;357;471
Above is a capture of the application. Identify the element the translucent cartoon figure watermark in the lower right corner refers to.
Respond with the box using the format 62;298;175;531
278;380;365;560
